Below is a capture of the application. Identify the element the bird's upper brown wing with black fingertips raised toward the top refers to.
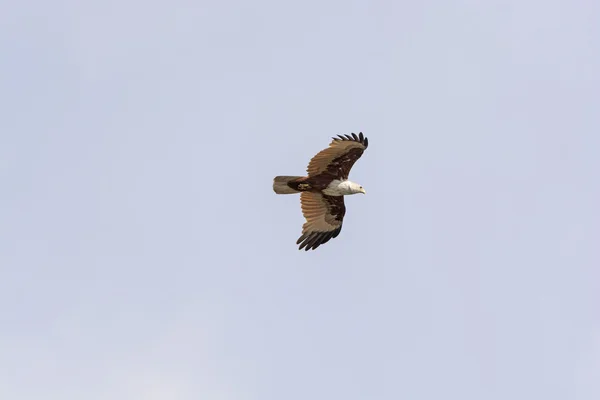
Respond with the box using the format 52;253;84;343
306;132;369;179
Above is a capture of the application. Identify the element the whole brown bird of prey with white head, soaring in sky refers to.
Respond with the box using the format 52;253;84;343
273;132;369;251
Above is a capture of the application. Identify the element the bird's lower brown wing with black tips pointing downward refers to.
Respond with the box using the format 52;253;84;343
296;192;346;251
